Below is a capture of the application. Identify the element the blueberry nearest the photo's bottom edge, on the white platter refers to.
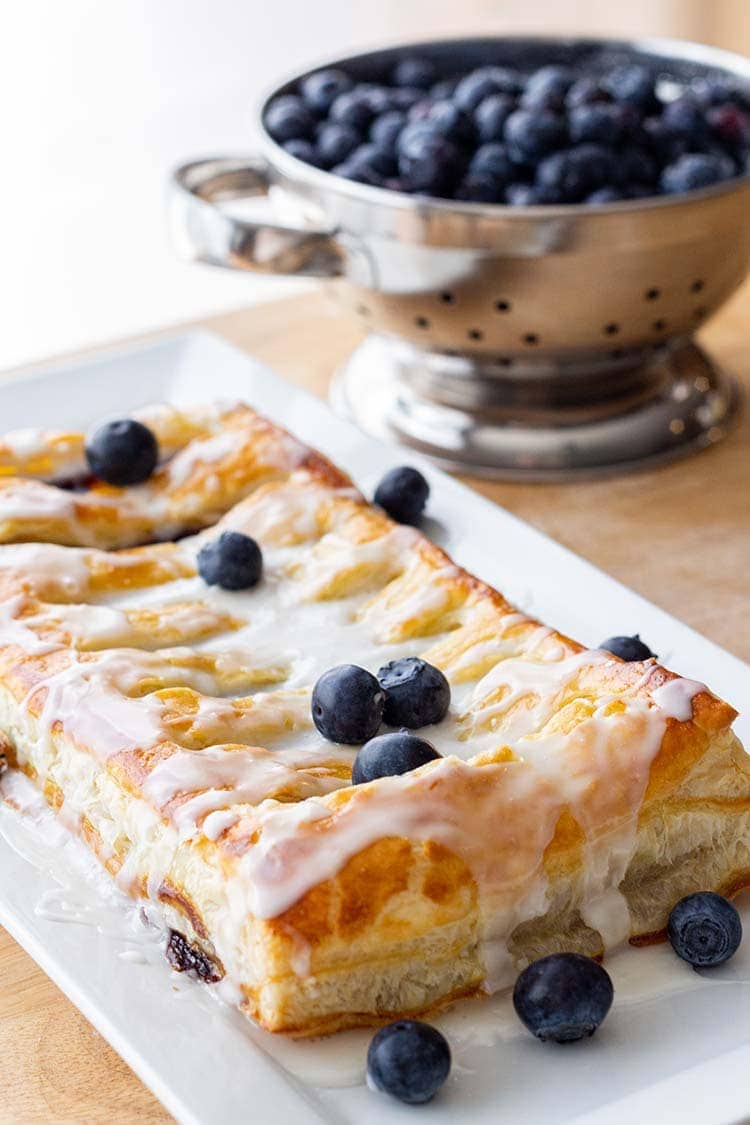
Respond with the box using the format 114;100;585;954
368;1019;451;1106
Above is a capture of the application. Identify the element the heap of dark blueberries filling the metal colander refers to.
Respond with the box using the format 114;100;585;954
264;55;750;206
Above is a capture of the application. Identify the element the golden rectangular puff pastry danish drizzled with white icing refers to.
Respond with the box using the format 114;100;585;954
0;406;750;1035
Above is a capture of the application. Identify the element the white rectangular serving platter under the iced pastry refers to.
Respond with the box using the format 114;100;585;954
0;333;750;1125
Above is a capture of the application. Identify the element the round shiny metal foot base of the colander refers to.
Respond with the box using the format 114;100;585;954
331;335;740;480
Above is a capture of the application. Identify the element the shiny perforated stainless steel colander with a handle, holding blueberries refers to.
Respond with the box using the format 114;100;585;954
172;38;750;479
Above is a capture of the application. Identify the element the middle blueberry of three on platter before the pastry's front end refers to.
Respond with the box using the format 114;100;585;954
513;953;614;1043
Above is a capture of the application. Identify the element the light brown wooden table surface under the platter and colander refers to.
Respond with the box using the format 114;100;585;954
0;285;750;1125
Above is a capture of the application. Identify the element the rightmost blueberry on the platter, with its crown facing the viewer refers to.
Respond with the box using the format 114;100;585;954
667;891;742;969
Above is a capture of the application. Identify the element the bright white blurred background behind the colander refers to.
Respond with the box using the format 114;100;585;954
0;0;750;369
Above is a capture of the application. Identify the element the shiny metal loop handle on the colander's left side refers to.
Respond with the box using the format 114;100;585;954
170;156;343;278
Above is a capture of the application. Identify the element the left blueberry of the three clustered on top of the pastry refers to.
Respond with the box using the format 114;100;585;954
311;664;386;746
